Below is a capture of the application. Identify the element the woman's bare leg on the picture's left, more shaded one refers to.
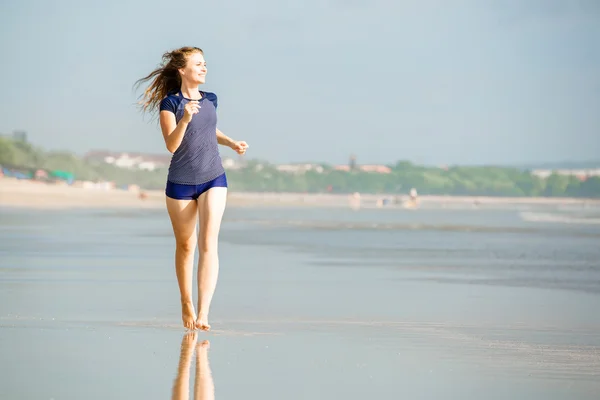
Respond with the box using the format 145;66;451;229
167;197;198;329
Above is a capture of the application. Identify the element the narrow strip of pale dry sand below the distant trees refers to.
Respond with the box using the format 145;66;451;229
0;178;600;209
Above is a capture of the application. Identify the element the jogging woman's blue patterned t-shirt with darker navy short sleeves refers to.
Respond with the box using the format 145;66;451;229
159;91;225;185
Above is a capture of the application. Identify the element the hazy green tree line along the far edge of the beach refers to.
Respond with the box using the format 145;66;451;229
0;137;600;198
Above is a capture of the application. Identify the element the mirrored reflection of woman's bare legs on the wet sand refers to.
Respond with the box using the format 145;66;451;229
171;332;215;400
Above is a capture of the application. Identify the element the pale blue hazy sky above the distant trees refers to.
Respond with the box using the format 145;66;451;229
0;0;600;165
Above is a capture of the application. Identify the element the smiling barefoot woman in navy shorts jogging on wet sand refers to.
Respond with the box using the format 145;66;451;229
136;47;248;331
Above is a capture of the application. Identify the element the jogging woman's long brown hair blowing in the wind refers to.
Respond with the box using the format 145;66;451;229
135;46;204;112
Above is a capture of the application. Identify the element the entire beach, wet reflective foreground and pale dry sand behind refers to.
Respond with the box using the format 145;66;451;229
0;180;600;400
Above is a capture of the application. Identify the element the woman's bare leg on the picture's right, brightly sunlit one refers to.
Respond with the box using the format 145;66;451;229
196;187;227;331
